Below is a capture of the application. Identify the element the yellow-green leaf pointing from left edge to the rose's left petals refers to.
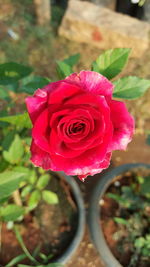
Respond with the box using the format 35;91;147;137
0;112;32;128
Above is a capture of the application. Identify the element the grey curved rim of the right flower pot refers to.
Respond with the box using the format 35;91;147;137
88;163;150;267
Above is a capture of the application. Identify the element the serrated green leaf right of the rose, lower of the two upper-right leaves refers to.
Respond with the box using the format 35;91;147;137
113;76;150;99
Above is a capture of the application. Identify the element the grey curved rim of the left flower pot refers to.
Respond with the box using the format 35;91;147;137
54;172;85;264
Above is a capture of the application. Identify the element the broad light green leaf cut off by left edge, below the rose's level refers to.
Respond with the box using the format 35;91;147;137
0;171;24;199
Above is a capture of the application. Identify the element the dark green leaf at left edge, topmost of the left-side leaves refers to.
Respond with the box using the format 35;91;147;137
0;62;32;85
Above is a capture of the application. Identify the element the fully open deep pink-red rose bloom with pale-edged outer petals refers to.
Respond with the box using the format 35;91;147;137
26;71;134;181
